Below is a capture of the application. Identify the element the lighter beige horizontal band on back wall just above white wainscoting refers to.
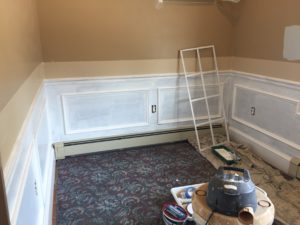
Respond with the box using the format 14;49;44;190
44;57;231;79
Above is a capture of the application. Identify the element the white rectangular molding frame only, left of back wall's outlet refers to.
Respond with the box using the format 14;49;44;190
61;89;150;134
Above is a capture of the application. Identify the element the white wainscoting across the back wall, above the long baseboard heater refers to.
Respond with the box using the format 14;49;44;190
46;74;220;142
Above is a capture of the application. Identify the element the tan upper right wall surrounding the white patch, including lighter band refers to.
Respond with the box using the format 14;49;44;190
232;0;300;82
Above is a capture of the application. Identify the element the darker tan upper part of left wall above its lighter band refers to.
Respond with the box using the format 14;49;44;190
0;0;41;111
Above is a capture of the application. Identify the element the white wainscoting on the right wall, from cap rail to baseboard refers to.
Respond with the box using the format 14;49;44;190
225;73;300;173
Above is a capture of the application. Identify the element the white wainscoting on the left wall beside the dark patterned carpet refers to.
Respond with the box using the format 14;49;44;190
4;86;55;225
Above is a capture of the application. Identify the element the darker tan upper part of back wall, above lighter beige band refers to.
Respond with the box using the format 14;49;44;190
39;0;232;62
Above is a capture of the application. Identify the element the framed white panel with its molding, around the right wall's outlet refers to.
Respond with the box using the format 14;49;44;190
232;85;300;150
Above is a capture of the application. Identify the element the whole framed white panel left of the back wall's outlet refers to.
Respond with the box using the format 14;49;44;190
61;89;150;134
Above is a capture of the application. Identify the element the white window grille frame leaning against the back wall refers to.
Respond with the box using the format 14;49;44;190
180;45;229;151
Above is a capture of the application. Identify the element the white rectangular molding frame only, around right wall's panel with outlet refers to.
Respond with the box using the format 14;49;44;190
231;84;300;150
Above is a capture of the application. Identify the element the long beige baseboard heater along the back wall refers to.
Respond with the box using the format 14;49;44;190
53;125;222;160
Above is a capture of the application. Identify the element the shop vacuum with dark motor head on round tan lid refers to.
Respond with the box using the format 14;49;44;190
192;167;275;225
